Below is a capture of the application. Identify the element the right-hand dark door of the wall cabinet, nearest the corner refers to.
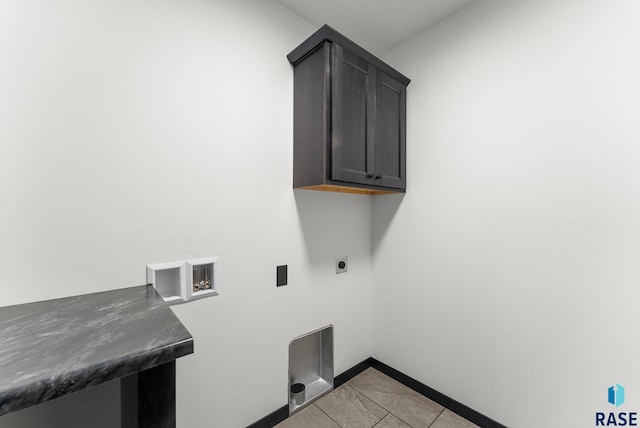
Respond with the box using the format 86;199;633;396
372;70;407;189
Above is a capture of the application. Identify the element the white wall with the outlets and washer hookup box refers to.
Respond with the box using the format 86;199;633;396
0;0;372;427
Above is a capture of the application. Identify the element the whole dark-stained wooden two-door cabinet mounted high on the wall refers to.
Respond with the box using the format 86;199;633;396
287;25;410;194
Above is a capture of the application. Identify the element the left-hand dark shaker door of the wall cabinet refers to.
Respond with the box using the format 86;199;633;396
331;43;375;184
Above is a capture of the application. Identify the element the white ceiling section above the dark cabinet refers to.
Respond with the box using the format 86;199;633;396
275;0;473;55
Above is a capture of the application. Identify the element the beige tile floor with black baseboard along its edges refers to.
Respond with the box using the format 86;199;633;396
276;368;477;428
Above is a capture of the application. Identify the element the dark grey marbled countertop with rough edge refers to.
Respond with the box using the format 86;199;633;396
0;285;193;415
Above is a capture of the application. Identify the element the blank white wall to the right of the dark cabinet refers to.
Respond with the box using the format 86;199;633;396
373;0;640;427
